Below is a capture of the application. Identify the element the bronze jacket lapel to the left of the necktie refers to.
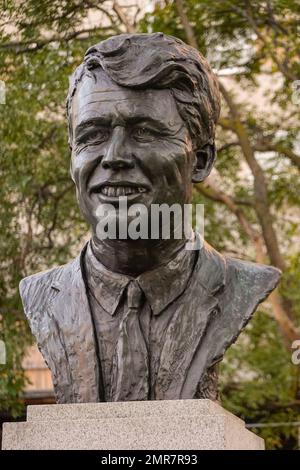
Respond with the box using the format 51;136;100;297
48;253;99;402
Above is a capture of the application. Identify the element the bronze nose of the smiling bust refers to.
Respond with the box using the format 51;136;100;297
101;126;134;170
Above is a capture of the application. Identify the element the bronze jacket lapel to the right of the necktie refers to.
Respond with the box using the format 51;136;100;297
156;244;225;400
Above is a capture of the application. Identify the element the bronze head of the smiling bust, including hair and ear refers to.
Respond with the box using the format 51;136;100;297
67;33;220;242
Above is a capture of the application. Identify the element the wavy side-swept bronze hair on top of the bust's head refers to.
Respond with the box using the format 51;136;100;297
66;33;220;150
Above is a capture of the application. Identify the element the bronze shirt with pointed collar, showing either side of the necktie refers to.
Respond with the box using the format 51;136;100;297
84;243;216;401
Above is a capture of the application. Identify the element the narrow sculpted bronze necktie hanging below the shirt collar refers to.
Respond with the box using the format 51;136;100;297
111;281;149;401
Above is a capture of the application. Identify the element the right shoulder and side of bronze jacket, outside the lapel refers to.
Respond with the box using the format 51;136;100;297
181;258;280;398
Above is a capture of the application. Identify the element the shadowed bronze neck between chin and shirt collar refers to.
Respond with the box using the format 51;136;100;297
91;238;186;277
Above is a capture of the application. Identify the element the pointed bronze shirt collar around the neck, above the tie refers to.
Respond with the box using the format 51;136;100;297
84;242;197;315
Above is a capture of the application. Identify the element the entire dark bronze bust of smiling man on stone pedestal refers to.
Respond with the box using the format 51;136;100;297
20;33;280;403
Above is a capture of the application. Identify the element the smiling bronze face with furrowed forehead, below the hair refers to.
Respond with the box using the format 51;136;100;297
71;71;195;239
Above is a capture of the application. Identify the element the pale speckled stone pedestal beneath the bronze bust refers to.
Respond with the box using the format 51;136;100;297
2;400;264;450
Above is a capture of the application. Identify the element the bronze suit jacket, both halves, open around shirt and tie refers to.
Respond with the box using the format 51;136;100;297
20;243;280;403
